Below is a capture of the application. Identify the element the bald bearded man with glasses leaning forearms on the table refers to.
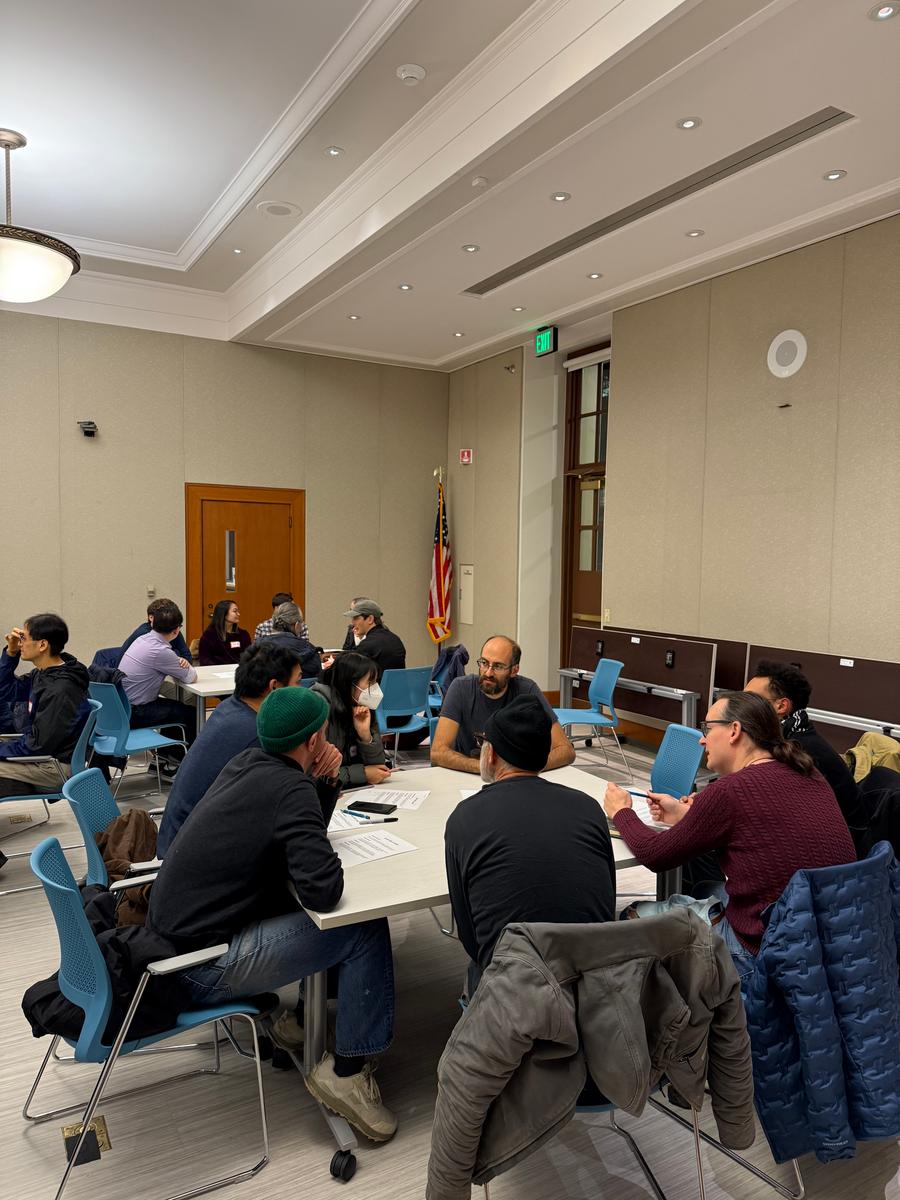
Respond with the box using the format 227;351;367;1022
431;635;575;775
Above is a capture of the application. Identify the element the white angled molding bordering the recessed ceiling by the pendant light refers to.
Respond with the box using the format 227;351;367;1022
42;0;418;271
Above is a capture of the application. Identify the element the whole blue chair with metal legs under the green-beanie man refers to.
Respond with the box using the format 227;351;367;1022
23;838;269;1200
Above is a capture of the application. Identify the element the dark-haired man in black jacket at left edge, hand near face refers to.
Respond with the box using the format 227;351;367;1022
0;612;90;797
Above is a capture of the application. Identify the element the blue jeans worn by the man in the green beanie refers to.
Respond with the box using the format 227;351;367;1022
184;910;394;1057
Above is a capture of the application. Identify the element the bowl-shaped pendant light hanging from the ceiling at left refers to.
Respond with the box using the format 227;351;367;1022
0;130;82;304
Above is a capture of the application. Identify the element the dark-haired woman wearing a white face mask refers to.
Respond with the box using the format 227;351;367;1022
312;652;390;787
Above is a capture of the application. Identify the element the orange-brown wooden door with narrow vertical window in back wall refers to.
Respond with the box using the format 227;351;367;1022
185;484;306;641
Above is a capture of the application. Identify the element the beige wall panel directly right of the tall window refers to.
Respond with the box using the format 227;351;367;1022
604;283;709;634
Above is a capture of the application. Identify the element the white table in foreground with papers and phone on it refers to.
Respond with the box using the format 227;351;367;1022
304;767;665;1151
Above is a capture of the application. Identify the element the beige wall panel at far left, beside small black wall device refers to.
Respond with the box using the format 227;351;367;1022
0;312;62;635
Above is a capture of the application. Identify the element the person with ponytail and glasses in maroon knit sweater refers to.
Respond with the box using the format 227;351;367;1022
604;691;856;954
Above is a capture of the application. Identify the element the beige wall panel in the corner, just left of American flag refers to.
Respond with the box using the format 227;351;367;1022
377;366;452;667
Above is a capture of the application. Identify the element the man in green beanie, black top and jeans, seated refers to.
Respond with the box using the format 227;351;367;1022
146;688;397;1141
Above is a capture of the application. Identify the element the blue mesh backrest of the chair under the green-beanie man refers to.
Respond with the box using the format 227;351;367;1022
31;838;113;1062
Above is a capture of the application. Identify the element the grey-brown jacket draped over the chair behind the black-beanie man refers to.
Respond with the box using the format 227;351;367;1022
426;908;755;1200
